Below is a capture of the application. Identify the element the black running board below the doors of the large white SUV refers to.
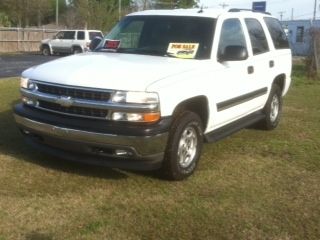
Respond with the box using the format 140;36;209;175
205;111;265;142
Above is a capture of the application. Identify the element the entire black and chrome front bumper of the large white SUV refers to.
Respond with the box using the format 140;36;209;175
14;104;170;170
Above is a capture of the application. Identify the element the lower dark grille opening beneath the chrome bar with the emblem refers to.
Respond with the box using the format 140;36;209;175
38;100;108;118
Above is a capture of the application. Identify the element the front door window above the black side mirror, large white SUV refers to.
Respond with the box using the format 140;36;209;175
218;18;247;58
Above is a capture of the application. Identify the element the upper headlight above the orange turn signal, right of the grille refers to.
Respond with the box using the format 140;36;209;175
112;91;159;104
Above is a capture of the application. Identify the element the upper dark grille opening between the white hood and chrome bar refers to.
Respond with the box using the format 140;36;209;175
37;83;110;101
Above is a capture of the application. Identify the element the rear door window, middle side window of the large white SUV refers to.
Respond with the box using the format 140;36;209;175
245;18;269;55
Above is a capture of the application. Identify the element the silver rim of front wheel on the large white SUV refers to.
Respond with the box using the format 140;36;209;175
178;127;198;168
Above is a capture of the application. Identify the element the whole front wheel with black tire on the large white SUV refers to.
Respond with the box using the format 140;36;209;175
162;111;203;180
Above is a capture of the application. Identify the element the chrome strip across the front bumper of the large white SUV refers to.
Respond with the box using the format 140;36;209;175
14;114;168;158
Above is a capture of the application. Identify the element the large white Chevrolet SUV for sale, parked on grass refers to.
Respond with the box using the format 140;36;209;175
14;9;292;180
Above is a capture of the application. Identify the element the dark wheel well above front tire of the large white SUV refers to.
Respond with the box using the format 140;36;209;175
174;96;209;129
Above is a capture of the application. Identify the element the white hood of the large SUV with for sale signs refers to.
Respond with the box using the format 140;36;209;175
22;53;199;91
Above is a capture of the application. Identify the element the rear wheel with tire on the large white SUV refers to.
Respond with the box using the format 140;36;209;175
260;84;282;130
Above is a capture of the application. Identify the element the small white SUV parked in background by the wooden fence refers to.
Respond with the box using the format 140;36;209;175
40;30;103;56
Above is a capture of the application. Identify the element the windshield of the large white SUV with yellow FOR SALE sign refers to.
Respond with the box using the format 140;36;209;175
99;16;215;59
